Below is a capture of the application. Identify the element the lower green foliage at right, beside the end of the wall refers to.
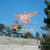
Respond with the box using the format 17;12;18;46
41;34;50;50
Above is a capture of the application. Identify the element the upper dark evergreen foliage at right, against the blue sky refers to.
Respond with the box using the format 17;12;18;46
44;0;50;28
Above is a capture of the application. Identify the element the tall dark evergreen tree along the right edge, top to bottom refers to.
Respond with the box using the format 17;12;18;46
41;0;50;50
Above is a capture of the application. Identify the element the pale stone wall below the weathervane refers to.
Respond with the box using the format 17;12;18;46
0;36;40;50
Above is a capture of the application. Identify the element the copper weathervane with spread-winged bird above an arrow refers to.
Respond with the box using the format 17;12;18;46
11;11;37;35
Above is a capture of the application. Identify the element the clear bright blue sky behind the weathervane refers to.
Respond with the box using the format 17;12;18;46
0;0;46;35
